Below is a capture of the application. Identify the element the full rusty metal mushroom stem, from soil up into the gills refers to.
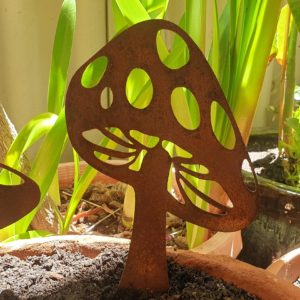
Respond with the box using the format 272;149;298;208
119;147;170;291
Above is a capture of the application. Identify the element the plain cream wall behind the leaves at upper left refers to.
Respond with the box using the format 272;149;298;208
0;0;105;130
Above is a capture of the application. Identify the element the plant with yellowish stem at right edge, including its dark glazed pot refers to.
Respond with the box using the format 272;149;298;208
240;1;300;267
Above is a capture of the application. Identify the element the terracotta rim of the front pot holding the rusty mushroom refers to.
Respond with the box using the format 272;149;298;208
0;236;300;300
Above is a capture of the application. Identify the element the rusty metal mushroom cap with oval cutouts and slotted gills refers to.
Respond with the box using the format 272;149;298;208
66;20;256;231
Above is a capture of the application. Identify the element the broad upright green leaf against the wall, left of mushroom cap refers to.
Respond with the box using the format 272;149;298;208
48;0;76;114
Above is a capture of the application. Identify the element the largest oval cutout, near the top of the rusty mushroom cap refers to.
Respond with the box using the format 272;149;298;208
156;29;190;70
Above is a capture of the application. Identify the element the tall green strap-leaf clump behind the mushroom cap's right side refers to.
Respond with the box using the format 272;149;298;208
107;1;281;254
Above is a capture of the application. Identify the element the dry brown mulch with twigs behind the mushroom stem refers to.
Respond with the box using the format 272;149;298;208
60;182;188;249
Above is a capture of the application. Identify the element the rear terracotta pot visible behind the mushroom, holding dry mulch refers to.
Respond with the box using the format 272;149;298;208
58;160;243;258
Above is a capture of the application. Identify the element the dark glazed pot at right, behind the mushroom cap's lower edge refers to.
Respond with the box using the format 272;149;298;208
239;169;300;268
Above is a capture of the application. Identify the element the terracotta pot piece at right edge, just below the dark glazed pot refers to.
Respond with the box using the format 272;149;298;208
267;248;300;283
